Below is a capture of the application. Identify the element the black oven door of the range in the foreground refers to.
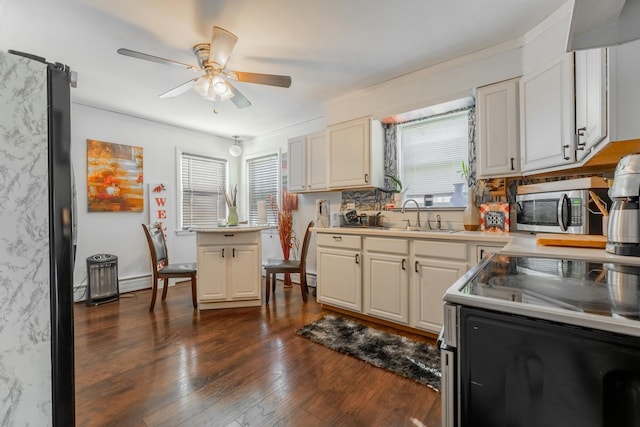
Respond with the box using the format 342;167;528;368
460;307;640;427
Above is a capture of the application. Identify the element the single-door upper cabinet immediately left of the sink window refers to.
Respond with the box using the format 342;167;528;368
328;117;384;189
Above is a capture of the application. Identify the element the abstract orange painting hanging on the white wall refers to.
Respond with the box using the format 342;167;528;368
87;139;144;212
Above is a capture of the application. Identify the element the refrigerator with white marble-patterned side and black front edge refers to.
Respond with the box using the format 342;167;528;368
0;52;75;427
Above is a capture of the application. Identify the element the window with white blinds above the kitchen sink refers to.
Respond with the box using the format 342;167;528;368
398;110;469;206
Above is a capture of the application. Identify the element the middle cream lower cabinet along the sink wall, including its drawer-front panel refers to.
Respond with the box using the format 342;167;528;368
363;237;409;325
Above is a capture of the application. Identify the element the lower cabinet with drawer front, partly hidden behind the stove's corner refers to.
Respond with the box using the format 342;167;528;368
411;240;467;334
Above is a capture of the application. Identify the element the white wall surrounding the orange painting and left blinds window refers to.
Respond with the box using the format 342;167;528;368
71;103;240;297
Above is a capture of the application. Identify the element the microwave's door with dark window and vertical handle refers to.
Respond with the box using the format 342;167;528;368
516;192;581;233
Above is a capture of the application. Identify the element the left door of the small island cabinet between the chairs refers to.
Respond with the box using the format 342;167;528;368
198;246;229;302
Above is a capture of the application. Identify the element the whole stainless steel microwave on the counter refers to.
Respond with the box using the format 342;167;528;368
516;188;610;234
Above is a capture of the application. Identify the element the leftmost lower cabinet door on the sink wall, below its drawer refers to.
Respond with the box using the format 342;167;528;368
317;247;362;313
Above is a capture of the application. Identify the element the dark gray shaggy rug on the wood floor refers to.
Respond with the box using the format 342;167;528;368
296;315;441;391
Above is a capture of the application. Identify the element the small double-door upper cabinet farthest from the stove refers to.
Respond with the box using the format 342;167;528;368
287;131;327;192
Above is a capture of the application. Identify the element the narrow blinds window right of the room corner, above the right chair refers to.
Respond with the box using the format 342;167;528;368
247;153;278;224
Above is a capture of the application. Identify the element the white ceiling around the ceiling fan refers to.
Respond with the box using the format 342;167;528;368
0;0;566;140
